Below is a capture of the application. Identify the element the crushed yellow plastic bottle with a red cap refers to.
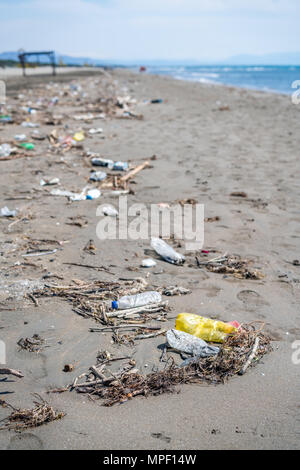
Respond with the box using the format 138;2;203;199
175;313;237;343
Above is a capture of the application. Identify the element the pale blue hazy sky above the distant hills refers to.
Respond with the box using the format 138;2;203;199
0;0;300;61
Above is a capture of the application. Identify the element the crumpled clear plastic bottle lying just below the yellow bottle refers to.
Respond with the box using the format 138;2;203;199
166;329;220;357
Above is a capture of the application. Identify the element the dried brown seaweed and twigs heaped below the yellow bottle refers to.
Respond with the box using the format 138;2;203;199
72;324;272;406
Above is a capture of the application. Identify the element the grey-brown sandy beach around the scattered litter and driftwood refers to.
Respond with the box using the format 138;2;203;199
0;69;300;450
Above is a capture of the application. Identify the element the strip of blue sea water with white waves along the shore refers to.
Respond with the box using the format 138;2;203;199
143;65;300;94
